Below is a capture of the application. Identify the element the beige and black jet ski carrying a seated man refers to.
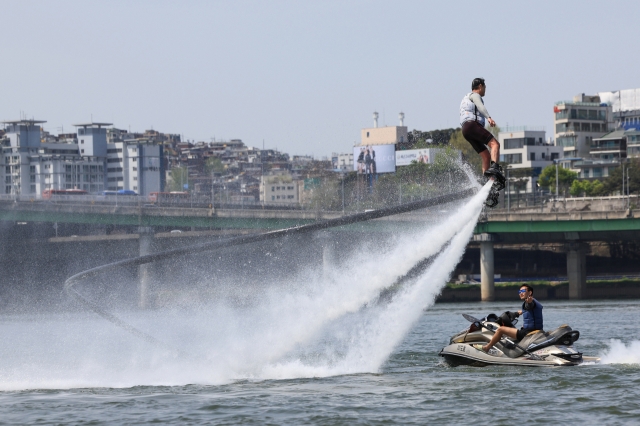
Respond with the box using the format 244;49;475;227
440;312;600;367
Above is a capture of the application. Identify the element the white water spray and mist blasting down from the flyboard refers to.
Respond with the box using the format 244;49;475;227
0;186;489;390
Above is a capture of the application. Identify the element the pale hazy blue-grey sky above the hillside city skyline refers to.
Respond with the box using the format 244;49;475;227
0;0;640;157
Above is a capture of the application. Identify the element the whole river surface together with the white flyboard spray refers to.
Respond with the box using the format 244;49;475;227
0;187;640;425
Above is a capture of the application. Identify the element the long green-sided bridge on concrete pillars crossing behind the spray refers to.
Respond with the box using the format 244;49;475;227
0;195;640;301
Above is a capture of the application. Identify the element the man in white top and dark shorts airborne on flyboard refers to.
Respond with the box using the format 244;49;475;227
460;78;505;207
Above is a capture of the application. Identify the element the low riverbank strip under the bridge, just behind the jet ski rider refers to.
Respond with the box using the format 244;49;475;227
436;278;640;303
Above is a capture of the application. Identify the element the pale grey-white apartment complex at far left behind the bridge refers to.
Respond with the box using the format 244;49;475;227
0;120;164;198
